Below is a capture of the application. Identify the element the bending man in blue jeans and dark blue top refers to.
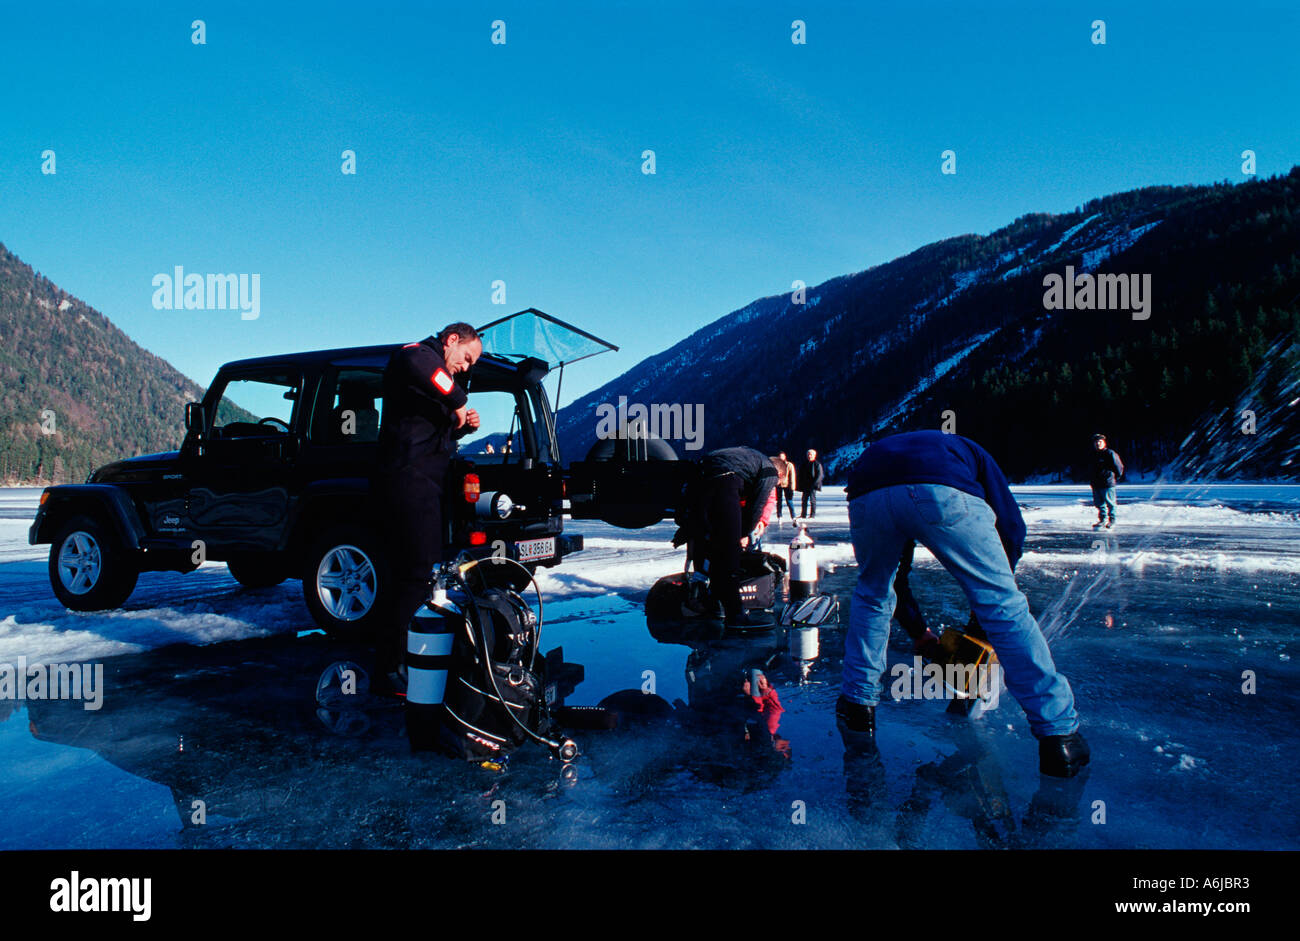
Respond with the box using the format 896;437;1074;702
836;432;1088;777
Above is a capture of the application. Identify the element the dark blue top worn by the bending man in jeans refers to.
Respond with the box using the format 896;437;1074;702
846;432;1026;568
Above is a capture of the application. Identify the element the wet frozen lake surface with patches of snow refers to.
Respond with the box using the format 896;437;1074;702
0;485;1300;850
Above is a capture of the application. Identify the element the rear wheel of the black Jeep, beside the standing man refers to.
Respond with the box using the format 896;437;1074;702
303;526;390;639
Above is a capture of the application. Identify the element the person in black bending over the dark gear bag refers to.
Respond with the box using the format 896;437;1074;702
673;447;776;626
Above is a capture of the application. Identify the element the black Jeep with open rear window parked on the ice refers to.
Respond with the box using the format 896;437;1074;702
29;309;686;634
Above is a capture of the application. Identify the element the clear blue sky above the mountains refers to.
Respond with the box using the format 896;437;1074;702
0;0;1300;400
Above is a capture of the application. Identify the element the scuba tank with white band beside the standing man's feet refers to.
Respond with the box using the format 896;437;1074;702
406;584;464;751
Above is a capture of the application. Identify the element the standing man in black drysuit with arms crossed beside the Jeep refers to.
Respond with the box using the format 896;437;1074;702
373;324;482;691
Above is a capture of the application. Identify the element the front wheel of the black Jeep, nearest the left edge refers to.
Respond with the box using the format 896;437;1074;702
49;516;140;611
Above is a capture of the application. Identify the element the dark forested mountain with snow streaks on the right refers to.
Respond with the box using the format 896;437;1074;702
559;168;1300;486
